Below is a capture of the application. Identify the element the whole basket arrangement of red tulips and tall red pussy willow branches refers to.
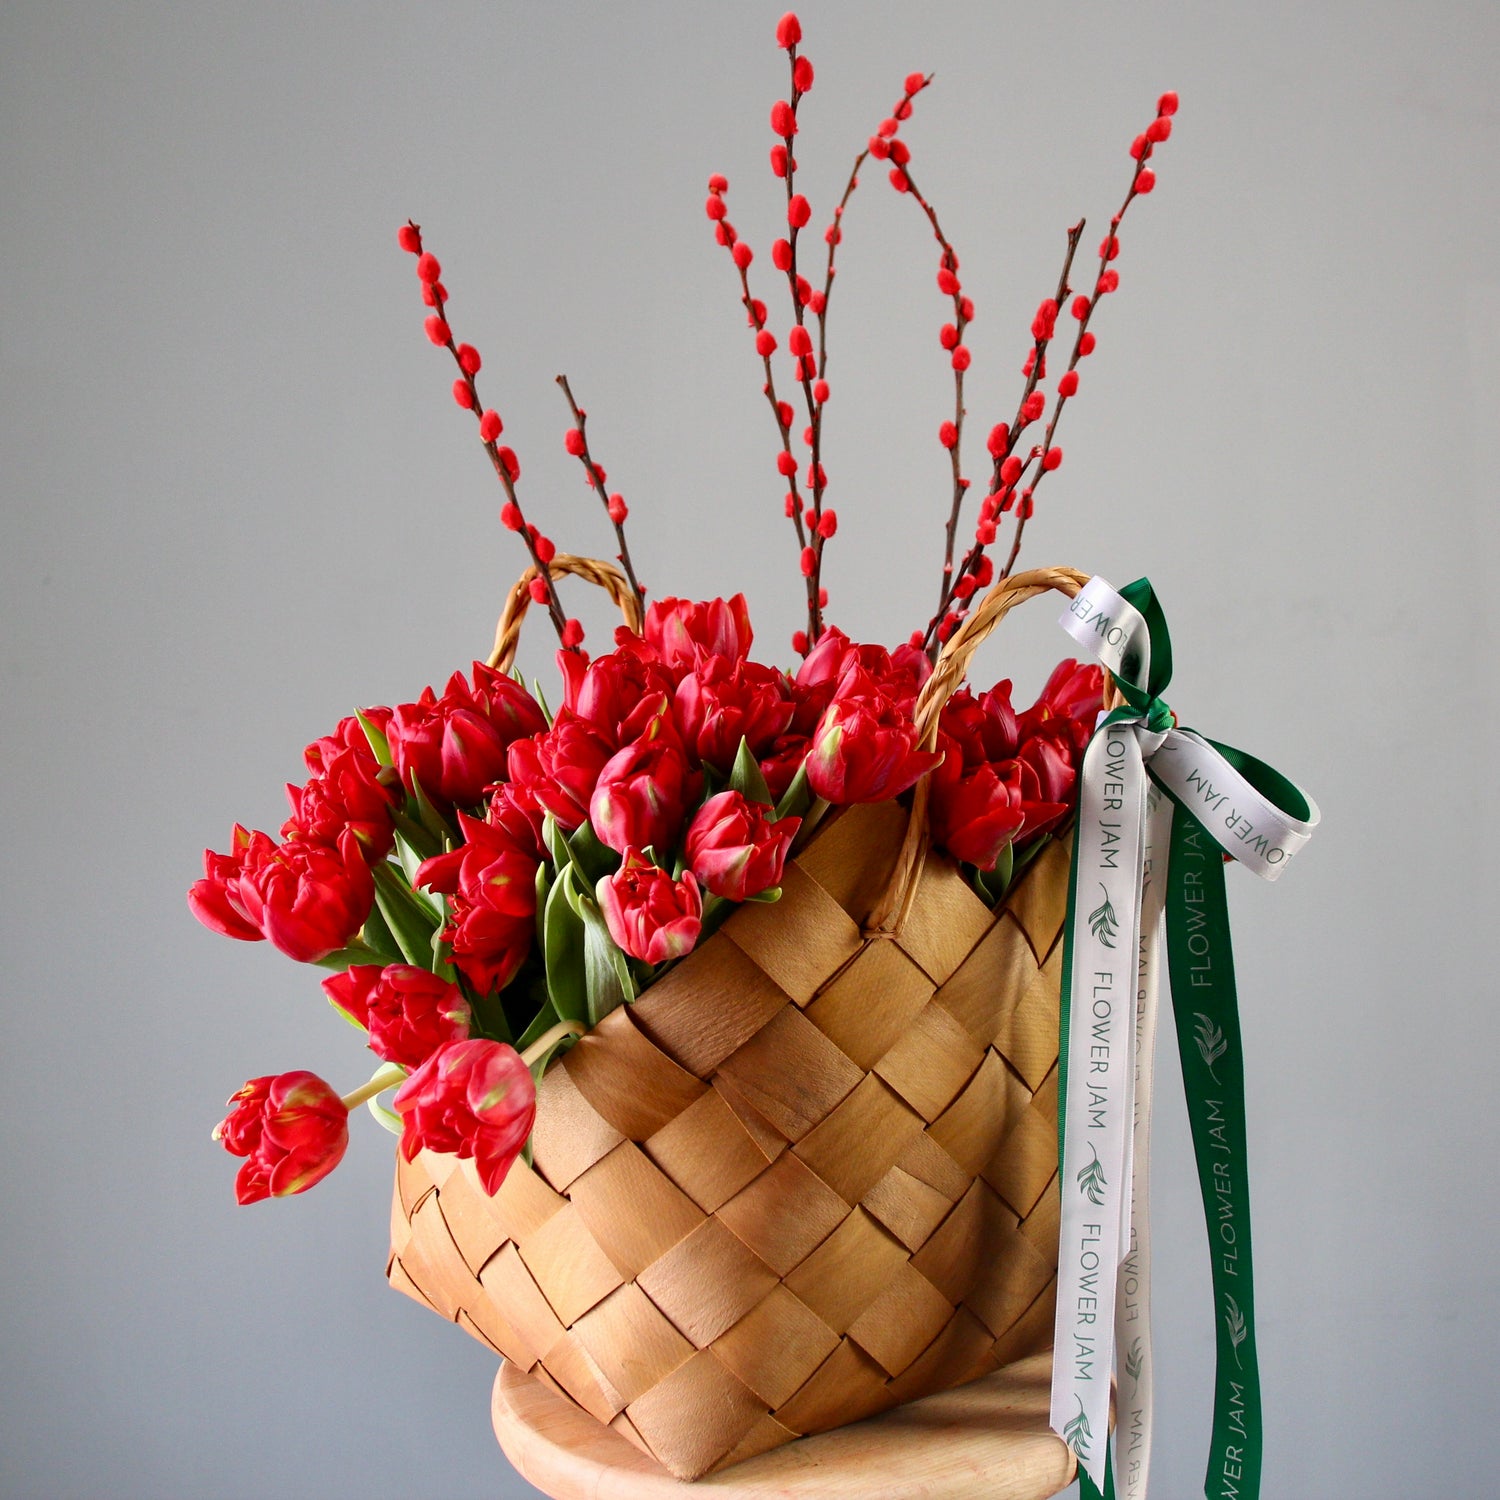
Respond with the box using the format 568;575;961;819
189;15;1311;1494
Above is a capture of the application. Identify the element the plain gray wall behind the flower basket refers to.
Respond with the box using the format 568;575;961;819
0;0;1500;1500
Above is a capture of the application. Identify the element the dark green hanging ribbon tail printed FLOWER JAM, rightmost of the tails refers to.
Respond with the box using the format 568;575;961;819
1167;804;1263;1500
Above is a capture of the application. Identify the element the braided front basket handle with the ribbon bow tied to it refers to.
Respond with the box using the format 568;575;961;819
864;567;1118;938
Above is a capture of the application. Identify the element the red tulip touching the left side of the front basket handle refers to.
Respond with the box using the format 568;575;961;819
807;668;942;803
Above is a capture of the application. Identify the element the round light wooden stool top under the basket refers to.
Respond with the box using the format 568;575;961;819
492;1355;1074;1500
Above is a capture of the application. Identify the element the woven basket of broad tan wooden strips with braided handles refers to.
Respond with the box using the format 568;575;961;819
389;558;1104;1479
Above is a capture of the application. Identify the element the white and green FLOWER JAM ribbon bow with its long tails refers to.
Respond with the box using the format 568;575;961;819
1052;578;1319;1500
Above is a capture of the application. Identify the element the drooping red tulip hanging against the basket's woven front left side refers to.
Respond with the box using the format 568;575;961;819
393;1038;537;1196
